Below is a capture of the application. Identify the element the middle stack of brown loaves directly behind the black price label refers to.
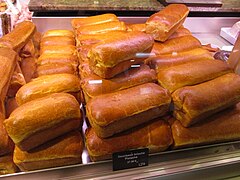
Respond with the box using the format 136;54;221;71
72;14;172;161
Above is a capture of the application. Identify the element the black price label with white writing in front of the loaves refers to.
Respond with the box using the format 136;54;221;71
112;148;149;171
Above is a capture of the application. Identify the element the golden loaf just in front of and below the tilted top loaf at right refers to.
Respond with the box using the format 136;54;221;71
152;35;201;55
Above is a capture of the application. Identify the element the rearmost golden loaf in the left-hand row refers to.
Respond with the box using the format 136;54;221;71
40;36;75;47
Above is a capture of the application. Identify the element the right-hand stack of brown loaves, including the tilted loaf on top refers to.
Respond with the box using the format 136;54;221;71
146;4;240;148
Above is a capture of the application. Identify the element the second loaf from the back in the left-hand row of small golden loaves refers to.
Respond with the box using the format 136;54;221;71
40;45;77;55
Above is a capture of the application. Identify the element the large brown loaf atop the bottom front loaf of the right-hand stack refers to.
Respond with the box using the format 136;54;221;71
172;73;240;127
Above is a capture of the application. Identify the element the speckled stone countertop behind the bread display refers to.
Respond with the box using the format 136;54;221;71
29;0;240;12
